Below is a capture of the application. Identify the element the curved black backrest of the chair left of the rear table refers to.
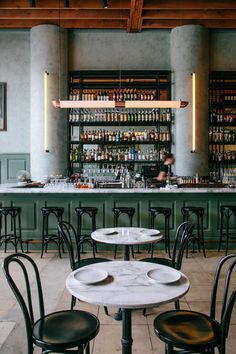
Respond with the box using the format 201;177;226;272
58;221;80;270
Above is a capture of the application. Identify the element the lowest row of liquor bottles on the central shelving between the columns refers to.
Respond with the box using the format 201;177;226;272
70;146;165;162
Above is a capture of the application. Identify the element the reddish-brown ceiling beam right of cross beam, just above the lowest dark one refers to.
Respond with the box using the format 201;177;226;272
143;9;236;20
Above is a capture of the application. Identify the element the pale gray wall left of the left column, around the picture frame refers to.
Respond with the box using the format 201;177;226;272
0;30;30;153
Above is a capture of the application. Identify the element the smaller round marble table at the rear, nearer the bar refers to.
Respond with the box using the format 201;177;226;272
91;227;163;261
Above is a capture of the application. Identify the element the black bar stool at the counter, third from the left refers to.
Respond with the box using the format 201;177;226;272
75;207;98;257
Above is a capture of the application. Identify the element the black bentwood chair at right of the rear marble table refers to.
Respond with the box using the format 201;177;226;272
140;221;194;314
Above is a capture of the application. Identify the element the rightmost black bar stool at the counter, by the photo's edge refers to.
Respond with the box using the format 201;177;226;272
218;205;236;255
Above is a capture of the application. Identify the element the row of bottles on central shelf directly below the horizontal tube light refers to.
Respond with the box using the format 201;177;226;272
69;109;171;123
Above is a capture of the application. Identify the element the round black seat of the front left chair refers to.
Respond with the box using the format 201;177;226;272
33;310;99;351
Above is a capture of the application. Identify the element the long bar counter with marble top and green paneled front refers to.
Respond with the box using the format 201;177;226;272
0;184;236;248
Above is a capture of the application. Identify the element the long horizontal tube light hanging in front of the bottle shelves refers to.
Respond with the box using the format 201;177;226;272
52;100;188;109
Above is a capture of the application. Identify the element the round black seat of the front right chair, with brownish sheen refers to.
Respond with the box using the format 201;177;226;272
154;310;220;350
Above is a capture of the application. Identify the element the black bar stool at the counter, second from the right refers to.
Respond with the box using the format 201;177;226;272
181;206;206;257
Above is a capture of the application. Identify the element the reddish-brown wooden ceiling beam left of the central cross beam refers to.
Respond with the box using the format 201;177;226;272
0;9;129;20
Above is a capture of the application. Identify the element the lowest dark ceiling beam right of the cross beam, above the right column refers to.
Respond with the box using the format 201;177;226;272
142;19;236;29
